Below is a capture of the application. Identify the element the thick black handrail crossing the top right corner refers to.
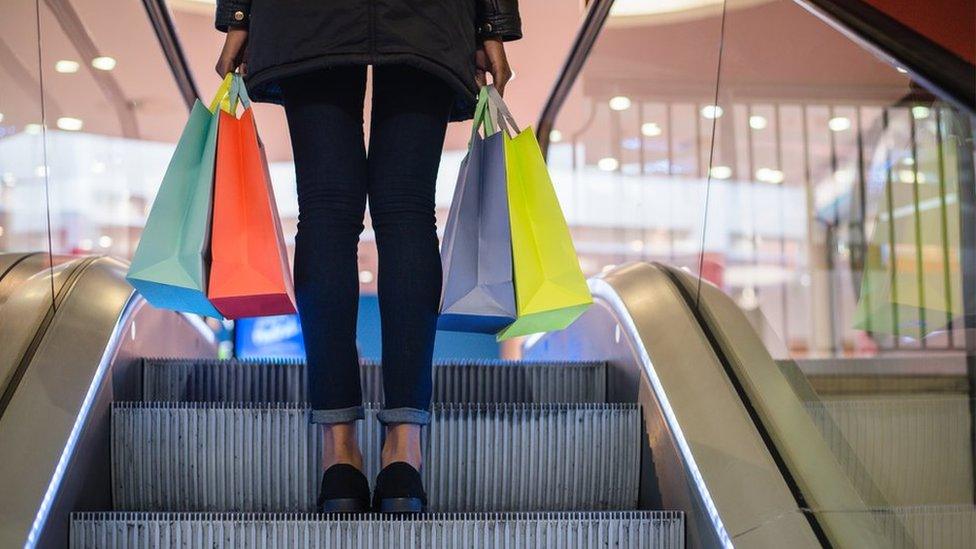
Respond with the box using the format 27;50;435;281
793;0;976;115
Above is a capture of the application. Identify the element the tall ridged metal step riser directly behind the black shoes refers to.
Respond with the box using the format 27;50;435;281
112;403;640;512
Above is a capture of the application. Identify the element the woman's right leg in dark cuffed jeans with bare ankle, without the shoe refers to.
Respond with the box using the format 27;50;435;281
368;66;454;468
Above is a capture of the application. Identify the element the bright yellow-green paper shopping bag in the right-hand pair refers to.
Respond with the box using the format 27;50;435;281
488;87;593;340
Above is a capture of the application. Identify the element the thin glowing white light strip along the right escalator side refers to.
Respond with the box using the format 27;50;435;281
587;278;734;549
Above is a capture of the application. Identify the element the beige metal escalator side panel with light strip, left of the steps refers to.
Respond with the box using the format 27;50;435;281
0;257;215;547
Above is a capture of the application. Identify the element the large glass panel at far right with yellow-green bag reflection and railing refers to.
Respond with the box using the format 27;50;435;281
702;0;976;547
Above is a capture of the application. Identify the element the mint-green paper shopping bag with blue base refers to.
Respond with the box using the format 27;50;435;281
126;76;232;318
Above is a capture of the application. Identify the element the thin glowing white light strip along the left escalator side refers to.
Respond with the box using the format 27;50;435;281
24;292;145;549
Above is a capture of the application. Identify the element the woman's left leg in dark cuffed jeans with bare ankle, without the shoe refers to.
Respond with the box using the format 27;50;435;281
281;67;374;469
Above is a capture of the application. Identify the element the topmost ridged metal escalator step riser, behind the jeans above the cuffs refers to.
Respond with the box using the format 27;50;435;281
143;358;606;402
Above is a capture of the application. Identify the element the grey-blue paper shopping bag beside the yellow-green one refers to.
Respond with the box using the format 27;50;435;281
437;89;516;334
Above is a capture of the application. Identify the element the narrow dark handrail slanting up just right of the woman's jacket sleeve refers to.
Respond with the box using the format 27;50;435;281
536;0;614;155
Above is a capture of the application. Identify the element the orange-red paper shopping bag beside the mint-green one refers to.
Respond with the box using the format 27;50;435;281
207;74;295;319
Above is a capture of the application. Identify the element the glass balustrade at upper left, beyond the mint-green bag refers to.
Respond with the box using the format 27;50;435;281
0;0;187;286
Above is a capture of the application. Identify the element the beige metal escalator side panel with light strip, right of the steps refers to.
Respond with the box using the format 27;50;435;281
526;264;820;547
